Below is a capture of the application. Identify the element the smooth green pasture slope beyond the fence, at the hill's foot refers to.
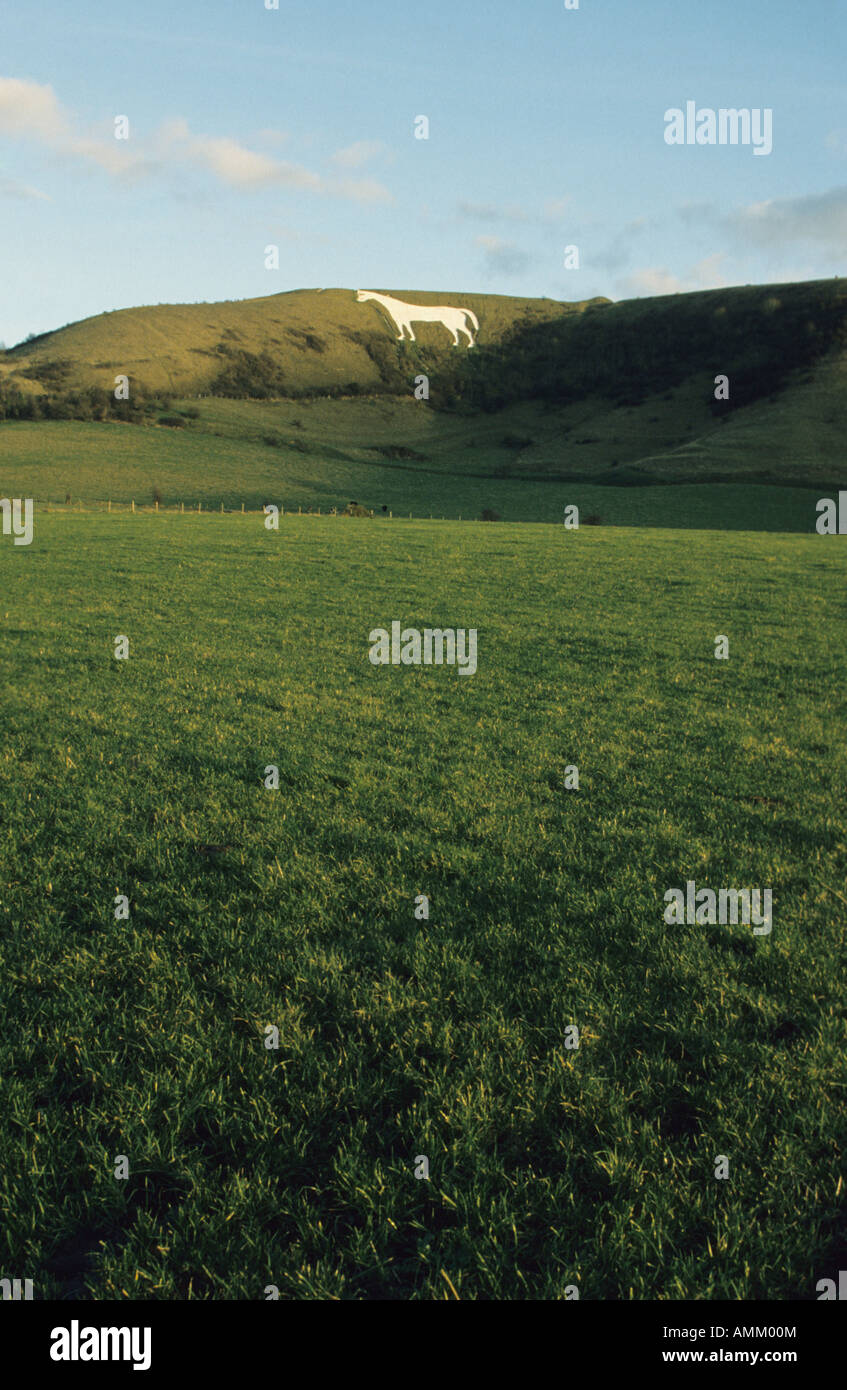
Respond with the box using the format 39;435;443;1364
0;400;836;532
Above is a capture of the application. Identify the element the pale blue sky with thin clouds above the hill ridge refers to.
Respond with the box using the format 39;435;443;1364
0;0;847;346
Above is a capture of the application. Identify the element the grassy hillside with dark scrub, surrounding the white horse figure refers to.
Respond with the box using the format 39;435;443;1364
0;279;847;505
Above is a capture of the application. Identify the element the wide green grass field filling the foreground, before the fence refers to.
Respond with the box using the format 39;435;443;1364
0;514;847;1300
